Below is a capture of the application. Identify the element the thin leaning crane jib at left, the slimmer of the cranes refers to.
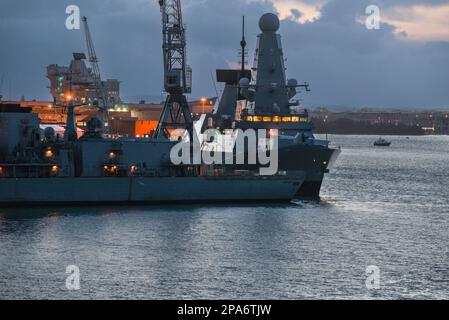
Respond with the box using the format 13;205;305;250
83;17;110;130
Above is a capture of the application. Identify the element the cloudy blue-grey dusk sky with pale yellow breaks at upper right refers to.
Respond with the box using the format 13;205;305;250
0;0;449;110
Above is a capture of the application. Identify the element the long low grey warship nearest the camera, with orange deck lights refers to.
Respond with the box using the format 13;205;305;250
0;105;305;206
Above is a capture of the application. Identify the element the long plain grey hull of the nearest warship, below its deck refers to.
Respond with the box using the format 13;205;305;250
0;174;305;206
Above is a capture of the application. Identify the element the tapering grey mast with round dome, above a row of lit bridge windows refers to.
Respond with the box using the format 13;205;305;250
239;14;309;130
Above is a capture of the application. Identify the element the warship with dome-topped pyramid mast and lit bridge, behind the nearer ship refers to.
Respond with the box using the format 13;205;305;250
203;13;341;198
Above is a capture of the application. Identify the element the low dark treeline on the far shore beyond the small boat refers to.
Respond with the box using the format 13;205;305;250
312;118;423;136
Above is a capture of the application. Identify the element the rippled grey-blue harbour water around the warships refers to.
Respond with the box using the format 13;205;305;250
0;136;449;299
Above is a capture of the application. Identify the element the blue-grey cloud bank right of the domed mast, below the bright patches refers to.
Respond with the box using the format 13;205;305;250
281;0;449;108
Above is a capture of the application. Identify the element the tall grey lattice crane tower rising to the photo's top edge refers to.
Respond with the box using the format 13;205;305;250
154;0;193;141
